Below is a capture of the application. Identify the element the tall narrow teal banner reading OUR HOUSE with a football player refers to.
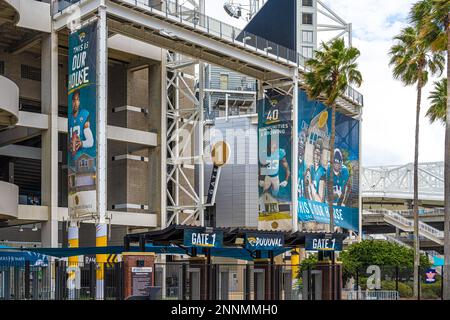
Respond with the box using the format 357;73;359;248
68;22;97;218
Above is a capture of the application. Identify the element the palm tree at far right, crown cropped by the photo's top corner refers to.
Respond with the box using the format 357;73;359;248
411;0;450;300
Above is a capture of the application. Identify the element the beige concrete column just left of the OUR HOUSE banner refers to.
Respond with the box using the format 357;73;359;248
41;32;58;247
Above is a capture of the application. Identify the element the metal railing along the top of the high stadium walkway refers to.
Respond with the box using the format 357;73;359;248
55;0;364;106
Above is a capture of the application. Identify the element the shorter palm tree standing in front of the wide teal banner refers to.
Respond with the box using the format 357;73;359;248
305;38;362;232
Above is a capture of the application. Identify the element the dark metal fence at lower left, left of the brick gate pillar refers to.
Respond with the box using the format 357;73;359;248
0;261;123;300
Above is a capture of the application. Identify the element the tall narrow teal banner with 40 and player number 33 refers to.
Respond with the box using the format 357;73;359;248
258;92;292;231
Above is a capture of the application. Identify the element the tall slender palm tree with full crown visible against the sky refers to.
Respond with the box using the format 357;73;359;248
389;26;445;297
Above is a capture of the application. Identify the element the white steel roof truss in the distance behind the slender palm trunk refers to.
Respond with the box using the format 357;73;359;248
361;162;444;201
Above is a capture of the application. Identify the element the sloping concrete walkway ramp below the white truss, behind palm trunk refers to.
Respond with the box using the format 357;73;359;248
363;209;444;246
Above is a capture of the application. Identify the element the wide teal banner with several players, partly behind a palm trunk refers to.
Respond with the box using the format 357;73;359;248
298;90;360;232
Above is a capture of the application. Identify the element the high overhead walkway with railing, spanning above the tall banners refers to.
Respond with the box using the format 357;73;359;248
54;0;363;116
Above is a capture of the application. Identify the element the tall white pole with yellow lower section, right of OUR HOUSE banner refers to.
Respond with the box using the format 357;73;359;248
95;3;108;300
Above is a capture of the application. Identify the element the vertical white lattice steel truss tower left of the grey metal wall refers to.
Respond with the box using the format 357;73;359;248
165;53;204;225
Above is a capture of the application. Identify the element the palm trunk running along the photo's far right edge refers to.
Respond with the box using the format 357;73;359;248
443;12;450;300
